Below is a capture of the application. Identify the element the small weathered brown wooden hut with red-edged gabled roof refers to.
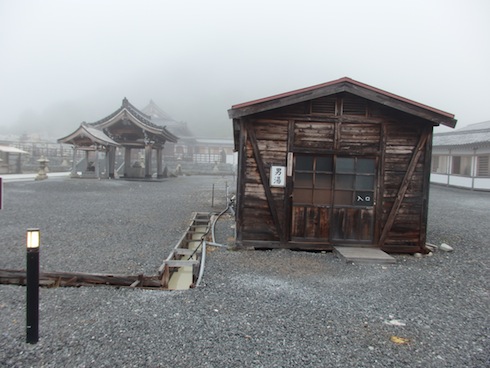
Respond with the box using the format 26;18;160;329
228;78;456;253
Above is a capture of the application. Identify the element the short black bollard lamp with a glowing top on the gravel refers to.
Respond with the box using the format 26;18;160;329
26;229;41;344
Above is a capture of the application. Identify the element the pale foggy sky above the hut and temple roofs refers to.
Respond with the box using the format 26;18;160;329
0;0;490;138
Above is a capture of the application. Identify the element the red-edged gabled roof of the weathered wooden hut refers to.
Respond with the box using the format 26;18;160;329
228;77;456;128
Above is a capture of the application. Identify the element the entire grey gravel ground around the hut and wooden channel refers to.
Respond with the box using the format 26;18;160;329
0;177;490;367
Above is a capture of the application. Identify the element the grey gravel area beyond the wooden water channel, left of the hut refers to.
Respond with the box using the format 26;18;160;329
0;176;232;274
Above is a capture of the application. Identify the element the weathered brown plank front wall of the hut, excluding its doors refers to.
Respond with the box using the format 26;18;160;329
236;93;432;253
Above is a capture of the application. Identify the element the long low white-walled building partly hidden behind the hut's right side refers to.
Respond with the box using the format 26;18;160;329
430;121;490;190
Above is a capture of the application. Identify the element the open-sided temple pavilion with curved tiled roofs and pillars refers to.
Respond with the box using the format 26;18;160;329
58;98;178;178
